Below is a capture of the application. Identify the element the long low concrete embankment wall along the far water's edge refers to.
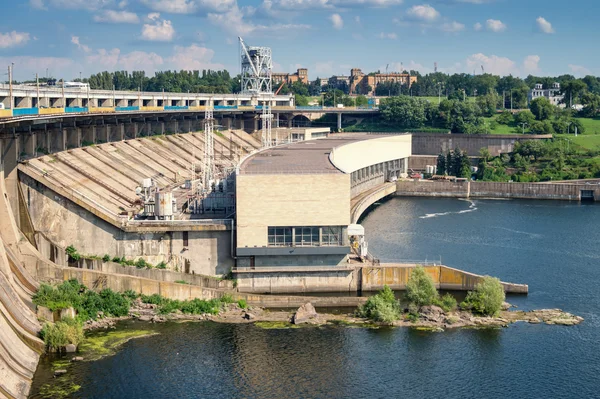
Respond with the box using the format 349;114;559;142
396;181;600;201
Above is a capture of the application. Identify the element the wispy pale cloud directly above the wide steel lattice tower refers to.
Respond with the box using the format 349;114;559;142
207;6;311;36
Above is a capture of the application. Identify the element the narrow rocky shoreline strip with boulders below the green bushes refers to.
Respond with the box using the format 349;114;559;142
84;300;583;331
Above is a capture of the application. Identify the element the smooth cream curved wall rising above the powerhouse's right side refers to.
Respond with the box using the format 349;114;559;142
329;134;412;173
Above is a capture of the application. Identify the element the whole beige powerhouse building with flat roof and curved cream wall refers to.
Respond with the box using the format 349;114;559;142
236;134;412;270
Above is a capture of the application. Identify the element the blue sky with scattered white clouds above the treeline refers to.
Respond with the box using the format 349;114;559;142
0;0;600;80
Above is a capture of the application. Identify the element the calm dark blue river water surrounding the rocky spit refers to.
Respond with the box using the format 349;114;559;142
32;198;600;399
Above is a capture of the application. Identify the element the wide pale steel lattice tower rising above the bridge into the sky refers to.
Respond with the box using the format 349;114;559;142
239;37;273;94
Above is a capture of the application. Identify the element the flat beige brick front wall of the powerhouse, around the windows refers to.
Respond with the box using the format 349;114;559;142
236;173;350;247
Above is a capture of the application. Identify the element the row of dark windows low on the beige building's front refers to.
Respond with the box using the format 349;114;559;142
268;226;343;247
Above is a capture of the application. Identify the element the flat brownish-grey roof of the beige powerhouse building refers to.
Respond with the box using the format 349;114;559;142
240;133;382;175
